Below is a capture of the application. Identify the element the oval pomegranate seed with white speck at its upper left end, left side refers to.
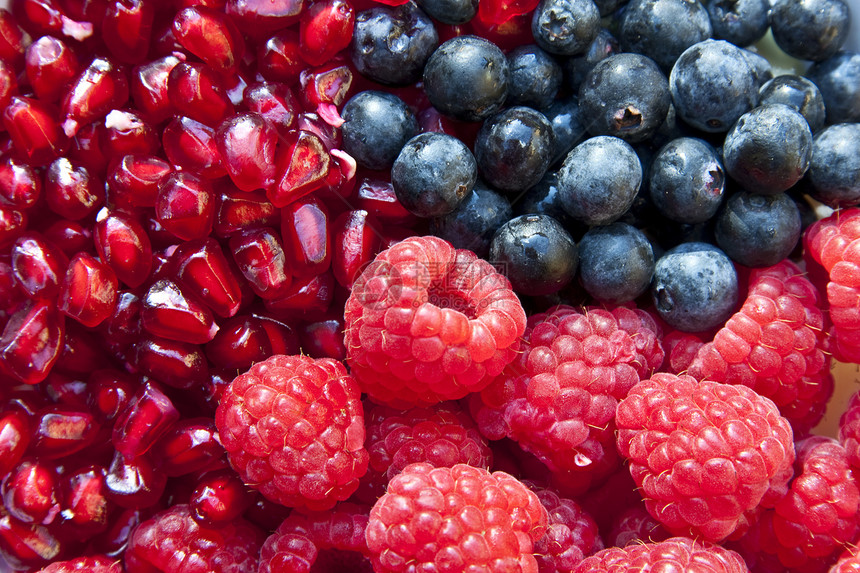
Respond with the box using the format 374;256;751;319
93;209;152;288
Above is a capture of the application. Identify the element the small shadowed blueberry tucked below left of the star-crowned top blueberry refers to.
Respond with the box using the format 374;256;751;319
507;44;562;109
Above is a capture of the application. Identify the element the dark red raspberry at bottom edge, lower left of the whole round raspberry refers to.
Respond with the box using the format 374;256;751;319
125;505;265;573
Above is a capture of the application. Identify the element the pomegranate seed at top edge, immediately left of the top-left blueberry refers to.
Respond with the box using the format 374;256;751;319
299;0;355;66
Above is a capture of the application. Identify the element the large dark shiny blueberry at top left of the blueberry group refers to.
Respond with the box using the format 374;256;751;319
349;2;439;85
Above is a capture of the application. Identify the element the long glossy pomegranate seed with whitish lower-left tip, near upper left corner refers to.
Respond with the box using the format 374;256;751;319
62;57;129;137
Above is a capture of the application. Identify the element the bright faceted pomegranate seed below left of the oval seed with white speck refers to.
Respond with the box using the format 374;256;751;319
59;253;119;328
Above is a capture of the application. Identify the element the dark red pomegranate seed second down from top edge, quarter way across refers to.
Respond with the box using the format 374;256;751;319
167;62;234;128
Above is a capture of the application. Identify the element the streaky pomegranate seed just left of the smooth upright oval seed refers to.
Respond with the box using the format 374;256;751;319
230;228;291;299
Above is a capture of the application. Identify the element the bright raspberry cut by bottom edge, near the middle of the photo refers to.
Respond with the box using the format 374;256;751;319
366;463;547;573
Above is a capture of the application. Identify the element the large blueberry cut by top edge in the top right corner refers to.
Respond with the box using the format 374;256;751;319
770;0;851;62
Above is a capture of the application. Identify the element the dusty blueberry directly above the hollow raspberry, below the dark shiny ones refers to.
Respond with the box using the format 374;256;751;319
391;132;478;217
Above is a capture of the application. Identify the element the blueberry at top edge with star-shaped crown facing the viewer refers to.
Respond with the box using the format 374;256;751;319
532;0;600;56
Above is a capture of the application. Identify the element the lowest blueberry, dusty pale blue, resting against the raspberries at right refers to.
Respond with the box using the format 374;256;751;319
651;242;738;332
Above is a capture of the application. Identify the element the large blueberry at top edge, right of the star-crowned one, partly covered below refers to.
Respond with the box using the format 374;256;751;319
618;0;712;71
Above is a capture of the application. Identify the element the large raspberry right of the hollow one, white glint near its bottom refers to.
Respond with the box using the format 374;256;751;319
470;306;663;495
